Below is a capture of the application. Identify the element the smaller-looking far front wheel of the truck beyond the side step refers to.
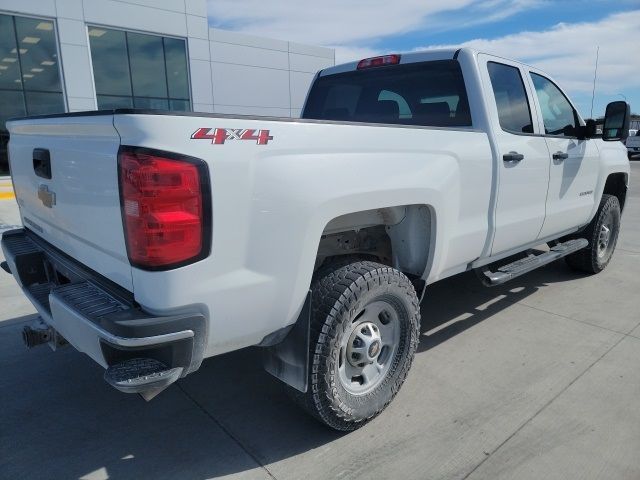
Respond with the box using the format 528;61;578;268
565;194;620;274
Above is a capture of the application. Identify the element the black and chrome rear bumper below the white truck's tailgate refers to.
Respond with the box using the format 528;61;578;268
2;229;206;376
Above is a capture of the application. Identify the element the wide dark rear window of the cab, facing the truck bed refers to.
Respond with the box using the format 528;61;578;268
302;60;471;127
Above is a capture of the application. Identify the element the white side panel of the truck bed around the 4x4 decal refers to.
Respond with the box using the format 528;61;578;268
114;114;492;355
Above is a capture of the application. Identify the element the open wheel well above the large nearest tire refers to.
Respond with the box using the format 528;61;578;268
315;205;435;277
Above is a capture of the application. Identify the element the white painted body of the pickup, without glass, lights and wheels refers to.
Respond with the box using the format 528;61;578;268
8;49;629;356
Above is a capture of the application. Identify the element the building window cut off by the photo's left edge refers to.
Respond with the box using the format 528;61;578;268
0;14;65;175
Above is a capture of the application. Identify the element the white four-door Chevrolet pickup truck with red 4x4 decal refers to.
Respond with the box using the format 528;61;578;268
2;48;629;430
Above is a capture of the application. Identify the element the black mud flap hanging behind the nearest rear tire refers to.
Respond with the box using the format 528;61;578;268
264;291;311;393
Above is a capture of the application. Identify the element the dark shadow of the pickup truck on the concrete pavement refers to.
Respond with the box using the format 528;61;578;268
0;262;580;479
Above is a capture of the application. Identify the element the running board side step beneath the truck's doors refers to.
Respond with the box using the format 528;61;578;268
476;238;589;287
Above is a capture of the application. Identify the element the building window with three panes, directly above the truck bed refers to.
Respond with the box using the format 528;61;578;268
89;27;191;111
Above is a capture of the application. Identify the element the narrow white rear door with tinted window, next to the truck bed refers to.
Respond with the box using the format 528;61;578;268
478;54;549;255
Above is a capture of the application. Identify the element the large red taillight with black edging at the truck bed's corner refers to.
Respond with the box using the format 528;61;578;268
118;148;208;269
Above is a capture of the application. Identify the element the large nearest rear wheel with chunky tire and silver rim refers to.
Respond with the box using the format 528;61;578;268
294;261;420;431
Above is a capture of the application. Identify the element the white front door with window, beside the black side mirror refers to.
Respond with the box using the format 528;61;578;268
530;72;600;237
